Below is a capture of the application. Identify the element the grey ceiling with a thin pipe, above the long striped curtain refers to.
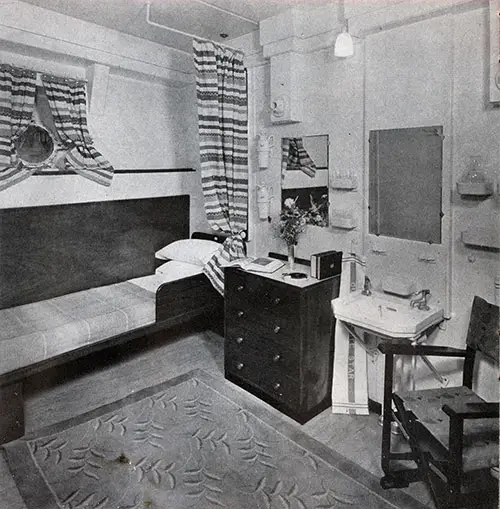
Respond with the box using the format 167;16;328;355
17;0;331;52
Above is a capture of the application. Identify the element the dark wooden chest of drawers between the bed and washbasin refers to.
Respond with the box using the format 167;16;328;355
224;267;340;423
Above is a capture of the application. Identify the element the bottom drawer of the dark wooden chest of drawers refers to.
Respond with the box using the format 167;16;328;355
224;352;300;407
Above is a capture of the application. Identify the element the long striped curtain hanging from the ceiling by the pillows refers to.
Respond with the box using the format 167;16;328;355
193;40;248;294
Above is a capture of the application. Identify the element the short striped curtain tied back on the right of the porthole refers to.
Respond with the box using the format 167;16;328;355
42;74;114;186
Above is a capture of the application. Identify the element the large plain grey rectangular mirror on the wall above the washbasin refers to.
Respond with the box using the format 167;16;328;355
369;126;443;244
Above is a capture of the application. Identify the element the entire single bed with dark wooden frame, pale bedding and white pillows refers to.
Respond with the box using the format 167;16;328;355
0;196;223;443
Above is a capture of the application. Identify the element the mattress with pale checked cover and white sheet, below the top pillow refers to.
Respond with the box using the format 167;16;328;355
0;262;201;376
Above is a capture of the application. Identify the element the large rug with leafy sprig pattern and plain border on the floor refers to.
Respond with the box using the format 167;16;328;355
5;370;425;509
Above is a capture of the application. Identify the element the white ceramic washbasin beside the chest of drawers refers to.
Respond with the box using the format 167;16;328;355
332;292;443;338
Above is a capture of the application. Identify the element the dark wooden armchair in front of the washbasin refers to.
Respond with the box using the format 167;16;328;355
379;296;499;509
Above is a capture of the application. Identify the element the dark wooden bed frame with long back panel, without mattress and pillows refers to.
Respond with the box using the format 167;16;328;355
0;195;224;444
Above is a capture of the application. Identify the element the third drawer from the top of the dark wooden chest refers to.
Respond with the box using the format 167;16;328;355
224;328;300;378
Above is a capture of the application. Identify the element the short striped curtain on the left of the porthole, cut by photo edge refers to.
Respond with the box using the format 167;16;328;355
0;65;36;191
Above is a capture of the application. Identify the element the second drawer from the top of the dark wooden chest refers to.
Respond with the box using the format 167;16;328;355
226;304;300;350
